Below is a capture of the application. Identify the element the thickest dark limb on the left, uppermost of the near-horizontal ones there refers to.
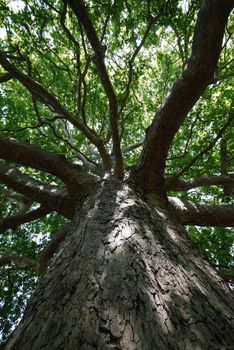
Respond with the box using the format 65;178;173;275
0;136;93;194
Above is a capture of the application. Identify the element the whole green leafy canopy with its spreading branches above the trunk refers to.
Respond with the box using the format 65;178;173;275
0;0;234;340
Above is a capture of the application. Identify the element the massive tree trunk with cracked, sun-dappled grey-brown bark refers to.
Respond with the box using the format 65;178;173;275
6;180;234;350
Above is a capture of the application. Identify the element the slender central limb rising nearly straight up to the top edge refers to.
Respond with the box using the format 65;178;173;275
66;0;123;176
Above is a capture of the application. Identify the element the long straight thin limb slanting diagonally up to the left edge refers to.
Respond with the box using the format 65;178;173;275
0;51;111;168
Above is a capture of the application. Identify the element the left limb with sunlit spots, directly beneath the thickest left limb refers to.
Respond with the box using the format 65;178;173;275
0;164;74;218
